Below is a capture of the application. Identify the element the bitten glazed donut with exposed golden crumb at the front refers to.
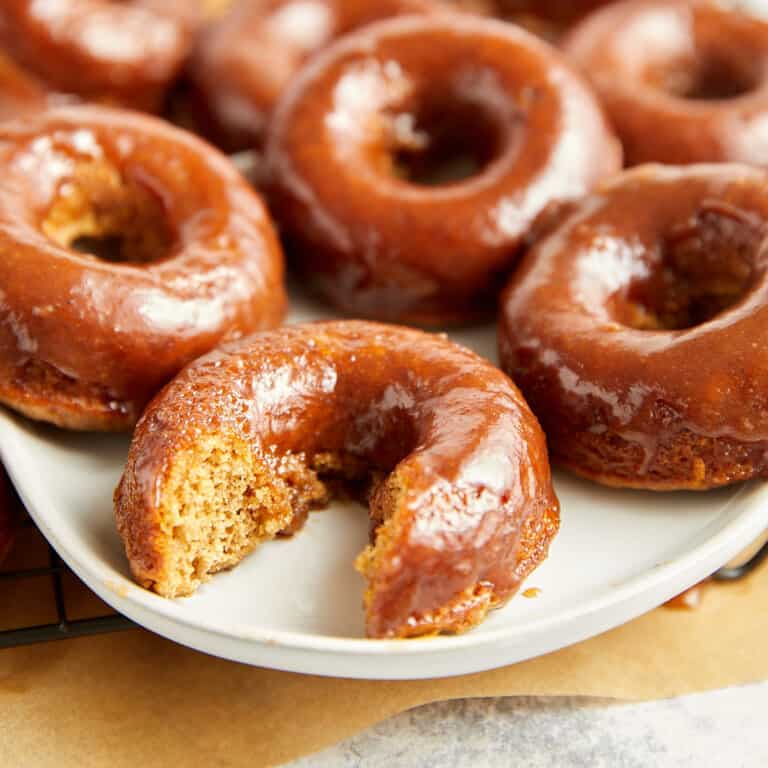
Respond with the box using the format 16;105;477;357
115;321;559;638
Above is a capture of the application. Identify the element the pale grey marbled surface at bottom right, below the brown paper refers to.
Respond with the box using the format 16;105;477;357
291;682;768;768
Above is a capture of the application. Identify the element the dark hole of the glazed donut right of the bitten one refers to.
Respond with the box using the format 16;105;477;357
614;209;763;331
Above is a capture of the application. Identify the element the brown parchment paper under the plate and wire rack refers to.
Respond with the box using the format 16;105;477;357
0;516;768;768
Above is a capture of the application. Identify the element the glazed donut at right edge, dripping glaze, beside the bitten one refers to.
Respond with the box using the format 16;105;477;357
500;164;768;490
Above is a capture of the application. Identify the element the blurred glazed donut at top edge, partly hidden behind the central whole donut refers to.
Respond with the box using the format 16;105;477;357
190;0;437;151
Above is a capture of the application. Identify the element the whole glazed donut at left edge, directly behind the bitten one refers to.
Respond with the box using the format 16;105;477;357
0;106;285;430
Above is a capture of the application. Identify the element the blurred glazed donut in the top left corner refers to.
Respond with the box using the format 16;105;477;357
0;0;199;111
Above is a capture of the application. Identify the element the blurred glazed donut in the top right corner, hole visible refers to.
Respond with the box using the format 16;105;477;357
563;0;768;166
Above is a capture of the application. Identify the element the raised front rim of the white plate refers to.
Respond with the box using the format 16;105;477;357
0;410;768;679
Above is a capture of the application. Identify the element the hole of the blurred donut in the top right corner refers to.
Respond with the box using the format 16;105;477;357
665;52;760;101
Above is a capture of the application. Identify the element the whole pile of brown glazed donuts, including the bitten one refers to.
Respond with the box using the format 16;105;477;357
0;0;768;638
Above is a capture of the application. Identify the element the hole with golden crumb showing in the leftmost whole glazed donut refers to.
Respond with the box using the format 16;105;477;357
42;163;173;264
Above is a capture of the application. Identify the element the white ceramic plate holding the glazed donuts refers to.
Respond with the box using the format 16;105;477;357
0;292;768;678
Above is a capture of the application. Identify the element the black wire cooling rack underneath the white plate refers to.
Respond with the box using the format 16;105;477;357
0;470;768;649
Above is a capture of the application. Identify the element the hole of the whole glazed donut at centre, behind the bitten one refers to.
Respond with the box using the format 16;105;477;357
391;101;501;186
